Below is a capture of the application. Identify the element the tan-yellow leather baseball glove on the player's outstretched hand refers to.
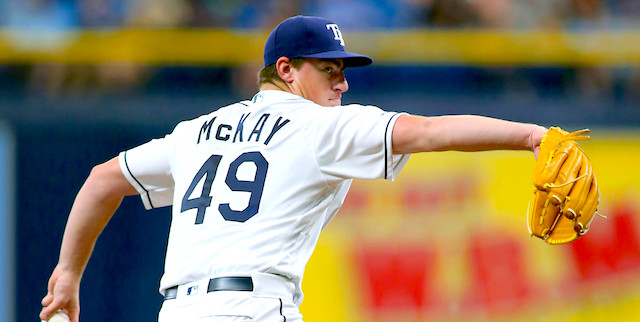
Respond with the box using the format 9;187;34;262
527;127;600;244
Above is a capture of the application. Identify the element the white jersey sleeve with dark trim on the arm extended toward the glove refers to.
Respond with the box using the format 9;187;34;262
315;105;410;181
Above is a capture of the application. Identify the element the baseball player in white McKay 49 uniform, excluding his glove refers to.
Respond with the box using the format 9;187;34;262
40;16;546;322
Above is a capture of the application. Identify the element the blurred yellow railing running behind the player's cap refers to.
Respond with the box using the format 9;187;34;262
0;29;640;66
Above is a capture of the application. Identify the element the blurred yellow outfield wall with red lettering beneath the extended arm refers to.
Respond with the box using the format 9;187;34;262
301;129;640;322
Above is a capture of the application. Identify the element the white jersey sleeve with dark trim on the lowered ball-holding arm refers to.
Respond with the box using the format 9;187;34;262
118;135;174;210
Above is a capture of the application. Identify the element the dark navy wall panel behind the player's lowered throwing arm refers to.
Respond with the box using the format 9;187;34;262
16;127;170;321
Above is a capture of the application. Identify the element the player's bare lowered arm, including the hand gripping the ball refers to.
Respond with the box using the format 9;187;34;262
40;157;138;322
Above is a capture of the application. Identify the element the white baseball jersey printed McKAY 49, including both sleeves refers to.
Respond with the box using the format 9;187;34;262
119;90;409;305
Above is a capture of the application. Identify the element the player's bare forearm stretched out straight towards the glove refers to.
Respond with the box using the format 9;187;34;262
392;114;547;156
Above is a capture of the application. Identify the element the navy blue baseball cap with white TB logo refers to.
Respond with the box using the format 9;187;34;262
264;16;373;67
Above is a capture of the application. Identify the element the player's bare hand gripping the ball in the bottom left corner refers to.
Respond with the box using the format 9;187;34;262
40;266;80;322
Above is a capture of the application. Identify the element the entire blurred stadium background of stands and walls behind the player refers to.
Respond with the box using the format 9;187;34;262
0;0;640;322
